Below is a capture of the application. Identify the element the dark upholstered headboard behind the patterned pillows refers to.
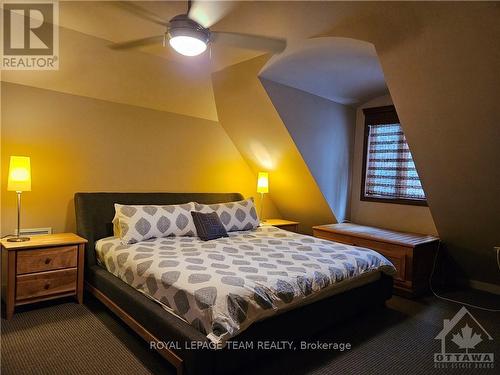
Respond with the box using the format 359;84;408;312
75;193;243;267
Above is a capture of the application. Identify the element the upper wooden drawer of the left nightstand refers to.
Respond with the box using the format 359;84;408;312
16;246;78;275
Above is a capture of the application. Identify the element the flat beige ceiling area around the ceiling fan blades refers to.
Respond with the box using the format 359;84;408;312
55;1;374;71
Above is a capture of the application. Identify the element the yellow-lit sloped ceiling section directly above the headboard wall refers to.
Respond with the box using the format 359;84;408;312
2;27;217;120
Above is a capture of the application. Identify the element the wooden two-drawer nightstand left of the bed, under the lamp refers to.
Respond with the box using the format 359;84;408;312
1;233;87;319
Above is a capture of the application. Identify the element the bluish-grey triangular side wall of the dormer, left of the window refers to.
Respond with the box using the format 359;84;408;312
261;78;355;222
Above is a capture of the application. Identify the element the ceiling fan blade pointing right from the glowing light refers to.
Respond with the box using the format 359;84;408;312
211;31;286;53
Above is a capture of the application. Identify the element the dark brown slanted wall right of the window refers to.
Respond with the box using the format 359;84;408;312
326;2;500;284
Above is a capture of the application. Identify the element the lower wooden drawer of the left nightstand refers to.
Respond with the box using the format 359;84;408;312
16;268;77;301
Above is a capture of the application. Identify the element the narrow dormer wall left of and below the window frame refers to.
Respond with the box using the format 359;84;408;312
351;95;437;235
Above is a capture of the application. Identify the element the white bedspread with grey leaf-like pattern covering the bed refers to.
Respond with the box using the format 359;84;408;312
96;226;395;344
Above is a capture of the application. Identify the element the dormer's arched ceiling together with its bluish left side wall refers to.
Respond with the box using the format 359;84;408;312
259;37;387;222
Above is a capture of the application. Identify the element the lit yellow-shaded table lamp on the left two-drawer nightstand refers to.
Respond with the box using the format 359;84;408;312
7;156;31;242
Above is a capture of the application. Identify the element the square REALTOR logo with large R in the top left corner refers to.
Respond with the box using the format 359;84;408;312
0;0;59;70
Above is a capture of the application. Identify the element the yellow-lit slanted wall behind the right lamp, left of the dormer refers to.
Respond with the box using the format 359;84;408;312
212;56;335;233
